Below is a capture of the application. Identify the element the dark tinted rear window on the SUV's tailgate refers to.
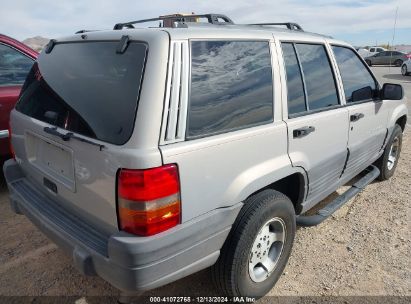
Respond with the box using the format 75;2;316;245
16;41;148;145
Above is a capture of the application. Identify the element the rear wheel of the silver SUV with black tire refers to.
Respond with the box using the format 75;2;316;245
211;190;296;298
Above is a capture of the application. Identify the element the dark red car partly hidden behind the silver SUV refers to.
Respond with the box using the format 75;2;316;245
0;34;38;158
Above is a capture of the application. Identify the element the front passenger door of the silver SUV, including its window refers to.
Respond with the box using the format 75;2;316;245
332;45;388;179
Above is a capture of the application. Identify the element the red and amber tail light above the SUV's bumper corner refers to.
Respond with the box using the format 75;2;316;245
117;164;181;236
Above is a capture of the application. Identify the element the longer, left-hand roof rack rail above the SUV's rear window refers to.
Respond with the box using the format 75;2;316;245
113;14;234;30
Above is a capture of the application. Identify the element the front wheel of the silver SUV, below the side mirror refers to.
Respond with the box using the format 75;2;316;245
375;125;402;181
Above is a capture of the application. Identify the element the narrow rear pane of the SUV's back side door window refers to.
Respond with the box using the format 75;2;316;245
282;43;306;115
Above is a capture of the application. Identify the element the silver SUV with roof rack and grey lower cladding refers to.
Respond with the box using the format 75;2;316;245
4;15;407;297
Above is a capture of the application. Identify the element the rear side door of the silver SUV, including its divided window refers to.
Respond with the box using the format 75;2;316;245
281;42;348;208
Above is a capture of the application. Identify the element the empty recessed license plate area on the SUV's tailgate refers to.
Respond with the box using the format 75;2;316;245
25;132;75;192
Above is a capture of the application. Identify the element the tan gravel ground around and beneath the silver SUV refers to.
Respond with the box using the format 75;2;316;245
0;67;411;303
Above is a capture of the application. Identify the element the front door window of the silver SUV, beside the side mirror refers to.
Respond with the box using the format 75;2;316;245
332;46;376;102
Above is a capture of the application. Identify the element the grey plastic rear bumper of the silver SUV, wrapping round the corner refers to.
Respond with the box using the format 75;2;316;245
3;160;242;292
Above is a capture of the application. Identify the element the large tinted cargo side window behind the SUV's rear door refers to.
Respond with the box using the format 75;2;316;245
187;41;273;138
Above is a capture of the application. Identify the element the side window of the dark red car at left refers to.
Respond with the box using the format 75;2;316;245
0;43;34;86
